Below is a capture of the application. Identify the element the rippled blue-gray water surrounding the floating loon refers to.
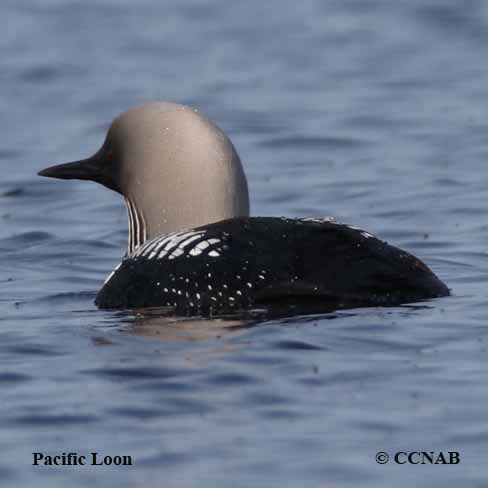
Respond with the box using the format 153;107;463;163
0;0;488;488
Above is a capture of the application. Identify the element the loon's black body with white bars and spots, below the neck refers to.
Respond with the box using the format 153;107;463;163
96;217;447;315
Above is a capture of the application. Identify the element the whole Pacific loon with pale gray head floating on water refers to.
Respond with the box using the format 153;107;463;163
39;102;449;316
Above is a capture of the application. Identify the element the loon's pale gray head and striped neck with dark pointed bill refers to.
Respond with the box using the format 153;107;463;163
39;102;249;252
